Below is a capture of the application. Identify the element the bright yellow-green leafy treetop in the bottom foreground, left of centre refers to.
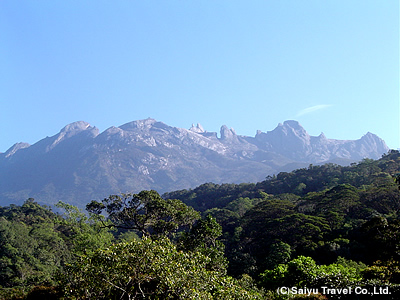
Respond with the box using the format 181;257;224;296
63;238;261;299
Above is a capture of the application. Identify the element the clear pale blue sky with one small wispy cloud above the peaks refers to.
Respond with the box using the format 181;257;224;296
0;0;400;152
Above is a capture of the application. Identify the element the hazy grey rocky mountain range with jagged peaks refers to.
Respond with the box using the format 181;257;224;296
0;118;389;206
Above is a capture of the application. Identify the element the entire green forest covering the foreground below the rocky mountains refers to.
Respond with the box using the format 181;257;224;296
0;150;400;299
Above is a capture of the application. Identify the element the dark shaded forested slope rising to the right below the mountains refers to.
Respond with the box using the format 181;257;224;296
161;151;400;276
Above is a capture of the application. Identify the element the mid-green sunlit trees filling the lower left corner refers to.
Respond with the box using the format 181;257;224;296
0;199;113;299
